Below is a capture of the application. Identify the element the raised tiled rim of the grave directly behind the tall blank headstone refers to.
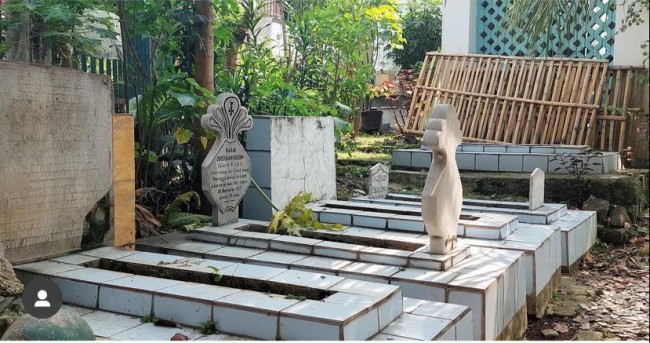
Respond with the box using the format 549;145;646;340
308;200;518;240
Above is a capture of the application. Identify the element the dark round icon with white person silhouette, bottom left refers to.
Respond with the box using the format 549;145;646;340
23;279;63;319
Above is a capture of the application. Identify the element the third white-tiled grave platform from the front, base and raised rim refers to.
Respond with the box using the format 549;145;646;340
312;200;564;317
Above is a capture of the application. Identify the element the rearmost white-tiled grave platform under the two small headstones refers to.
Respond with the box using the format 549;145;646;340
350;193;596;273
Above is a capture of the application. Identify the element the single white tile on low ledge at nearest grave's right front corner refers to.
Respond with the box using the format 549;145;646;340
382;313;451;341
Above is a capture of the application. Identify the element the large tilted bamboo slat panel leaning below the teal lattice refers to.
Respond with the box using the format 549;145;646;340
405;52;608;145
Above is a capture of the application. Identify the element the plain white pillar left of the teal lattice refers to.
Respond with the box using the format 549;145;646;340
440;0;478;54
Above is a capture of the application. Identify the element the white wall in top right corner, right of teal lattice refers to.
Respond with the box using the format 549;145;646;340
612;4;649;66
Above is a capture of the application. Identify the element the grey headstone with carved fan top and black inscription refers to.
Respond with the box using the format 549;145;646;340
201;93;253;225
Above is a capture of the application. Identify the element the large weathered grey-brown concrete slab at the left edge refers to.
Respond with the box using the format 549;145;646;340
0;61;113;263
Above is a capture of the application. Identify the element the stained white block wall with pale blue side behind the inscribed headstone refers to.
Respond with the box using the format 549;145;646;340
241;116;336;220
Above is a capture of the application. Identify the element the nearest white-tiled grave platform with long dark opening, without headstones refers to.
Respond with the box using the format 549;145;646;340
15;249;473;340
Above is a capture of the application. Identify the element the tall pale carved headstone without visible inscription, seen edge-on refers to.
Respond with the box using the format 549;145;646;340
422;105;463;254
